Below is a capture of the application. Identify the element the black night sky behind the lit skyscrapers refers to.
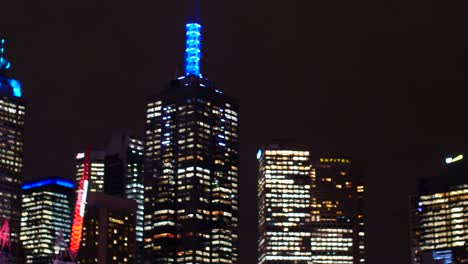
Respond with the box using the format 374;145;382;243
0;0;468;264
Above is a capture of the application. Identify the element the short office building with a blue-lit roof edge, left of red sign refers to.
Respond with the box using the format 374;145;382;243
20;177;74;264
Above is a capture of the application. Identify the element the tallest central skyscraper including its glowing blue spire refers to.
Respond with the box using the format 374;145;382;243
145;23;239;263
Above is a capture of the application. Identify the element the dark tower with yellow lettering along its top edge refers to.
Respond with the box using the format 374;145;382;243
310;156;366;264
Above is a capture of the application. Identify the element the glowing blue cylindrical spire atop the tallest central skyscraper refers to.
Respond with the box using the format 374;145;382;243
185;23;202;77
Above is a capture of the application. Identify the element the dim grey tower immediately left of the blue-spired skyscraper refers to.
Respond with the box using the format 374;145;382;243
104;130;145;263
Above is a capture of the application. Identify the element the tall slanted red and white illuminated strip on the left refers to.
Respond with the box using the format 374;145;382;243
70;151;90;258
